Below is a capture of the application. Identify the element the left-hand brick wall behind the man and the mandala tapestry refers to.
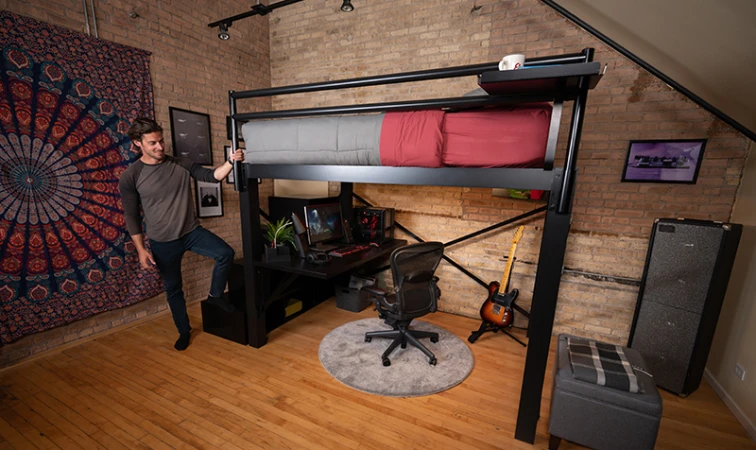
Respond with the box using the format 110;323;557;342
0;0;272;367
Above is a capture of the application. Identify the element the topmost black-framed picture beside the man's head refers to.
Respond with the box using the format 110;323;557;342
168;107;213;166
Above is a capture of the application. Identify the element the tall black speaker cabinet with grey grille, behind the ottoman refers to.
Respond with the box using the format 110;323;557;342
629;219;743;396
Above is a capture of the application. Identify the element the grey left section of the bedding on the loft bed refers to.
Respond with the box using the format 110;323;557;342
242;114;383;166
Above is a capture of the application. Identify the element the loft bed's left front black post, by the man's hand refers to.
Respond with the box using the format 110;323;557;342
233;91;268;348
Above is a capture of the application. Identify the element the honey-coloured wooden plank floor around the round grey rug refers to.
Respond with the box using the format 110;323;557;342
0;300;756;450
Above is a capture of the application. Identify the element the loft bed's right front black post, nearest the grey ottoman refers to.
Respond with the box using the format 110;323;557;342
515;48;593;444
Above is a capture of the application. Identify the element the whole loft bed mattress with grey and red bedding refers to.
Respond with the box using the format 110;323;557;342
242;103;551;167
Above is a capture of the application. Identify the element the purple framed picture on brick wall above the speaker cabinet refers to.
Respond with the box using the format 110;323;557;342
622;139;706;184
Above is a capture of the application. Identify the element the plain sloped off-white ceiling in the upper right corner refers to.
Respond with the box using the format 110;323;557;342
556;0;756;138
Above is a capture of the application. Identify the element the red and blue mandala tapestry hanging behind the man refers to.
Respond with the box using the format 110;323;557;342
0;11;162;345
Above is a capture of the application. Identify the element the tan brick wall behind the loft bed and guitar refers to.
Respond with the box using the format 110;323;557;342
271;0;749;342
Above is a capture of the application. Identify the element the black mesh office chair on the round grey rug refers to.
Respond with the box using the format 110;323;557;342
362;242;444;366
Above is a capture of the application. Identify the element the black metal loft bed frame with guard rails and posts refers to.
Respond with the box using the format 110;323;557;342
229;48;601;443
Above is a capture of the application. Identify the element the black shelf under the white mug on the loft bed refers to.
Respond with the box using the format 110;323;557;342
478;62;601;100
